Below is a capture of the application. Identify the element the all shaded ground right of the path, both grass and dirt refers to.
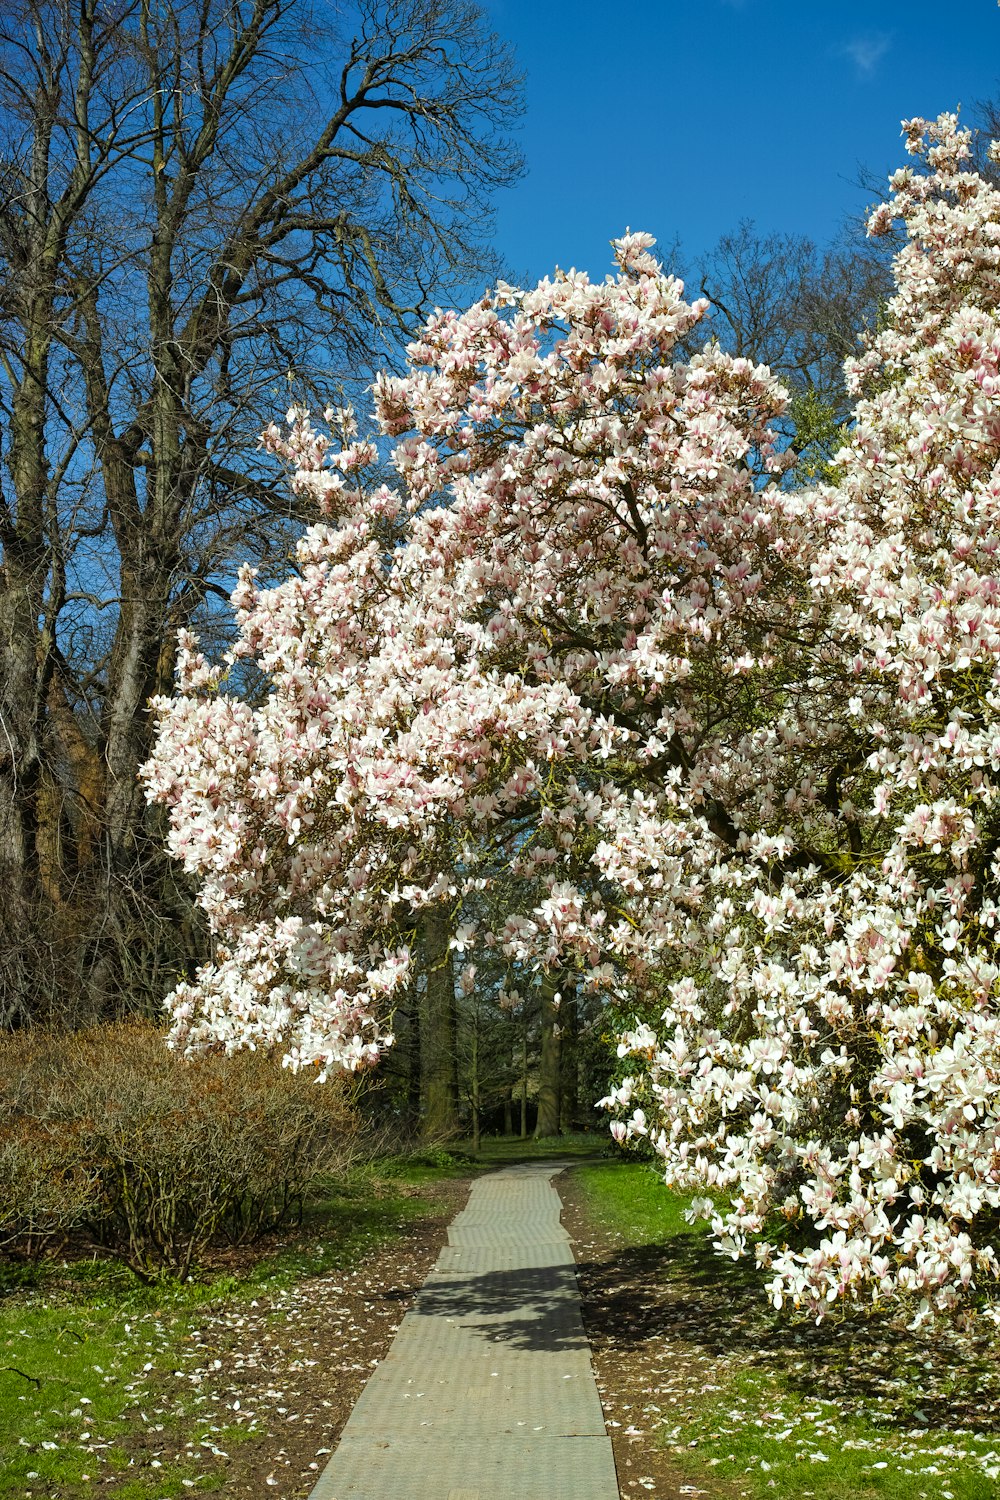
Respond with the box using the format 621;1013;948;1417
558;1160;1000;1500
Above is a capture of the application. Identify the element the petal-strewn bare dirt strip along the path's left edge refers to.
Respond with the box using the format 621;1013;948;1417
113;1181;469;1500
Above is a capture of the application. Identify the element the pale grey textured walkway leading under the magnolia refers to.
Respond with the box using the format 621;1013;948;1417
310;1163;619;1500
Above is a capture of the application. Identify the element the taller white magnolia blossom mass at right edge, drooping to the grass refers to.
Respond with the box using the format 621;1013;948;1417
606;116;1000;1323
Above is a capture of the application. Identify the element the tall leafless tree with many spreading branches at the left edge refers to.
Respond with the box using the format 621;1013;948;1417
0;0;520;1026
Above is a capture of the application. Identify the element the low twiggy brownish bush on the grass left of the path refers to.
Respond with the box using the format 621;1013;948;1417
0;1022;357;1280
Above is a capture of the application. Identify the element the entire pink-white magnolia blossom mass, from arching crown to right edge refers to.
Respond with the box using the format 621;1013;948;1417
144;117;1000;1320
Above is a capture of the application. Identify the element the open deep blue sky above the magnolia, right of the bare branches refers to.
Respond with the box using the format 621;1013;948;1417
481;0;1000;282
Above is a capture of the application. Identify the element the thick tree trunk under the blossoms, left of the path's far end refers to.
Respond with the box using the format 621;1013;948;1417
420;906;459;1140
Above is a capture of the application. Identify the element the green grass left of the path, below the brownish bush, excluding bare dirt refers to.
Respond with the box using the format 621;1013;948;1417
0;1166;450;1500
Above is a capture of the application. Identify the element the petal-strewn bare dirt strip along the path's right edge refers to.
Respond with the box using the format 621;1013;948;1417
556;1172;735;1500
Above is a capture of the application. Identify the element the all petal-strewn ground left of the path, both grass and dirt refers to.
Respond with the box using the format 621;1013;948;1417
0;1158;469;1500
